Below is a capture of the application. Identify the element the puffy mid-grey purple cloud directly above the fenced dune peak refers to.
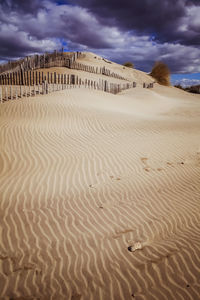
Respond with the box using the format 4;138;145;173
18;3;111;48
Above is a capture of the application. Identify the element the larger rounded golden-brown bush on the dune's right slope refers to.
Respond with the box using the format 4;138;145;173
150;62;170;86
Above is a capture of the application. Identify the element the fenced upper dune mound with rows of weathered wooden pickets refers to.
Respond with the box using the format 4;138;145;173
0;52;154;103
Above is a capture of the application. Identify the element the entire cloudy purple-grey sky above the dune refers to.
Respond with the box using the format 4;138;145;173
0;0;200;85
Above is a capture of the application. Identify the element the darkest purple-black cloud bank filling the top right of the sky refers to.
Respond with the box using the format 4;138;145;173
68;0;200;45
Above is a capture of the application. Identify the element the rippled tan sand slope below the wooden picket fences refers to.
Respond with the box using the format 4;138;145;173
0;74;200;300
